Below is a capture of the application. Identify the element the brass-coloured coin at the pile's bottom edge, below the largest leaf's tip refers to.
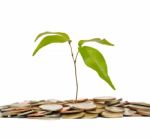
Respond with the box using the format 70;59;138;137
101;111;123;118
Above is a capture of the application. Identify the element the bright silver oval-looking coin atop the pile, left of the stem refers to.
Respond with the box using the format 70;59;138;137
39;104;63;111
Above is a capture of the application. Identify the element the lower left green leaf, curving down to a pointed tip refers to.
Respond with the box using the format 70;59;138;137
32;35;68;56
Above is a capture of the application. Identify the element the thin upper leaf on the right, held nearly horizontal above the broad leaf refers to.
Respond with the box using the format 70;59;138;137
78;38;114;46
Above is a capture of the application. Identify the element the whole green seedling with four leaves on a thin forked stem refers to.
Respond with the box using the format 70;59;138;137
32;32;115;100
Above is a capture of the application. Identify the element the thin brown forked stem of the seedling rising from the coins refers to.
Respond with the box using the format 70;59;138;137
69;41;79;101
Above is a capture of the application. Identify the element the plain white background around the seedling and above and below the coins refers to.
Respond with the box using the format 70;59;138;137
0;0;150;139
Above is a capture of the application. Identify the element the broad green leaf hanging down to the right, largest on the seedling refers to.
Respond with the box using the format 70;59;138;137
79;46;115;90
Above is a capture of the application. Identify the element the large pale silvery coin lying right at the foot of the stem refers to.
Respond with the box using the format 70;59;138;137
71;102;96;110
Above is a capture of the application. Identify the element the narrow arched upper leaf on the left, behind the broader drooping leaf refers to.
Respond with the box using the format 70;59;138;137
35;31;70;41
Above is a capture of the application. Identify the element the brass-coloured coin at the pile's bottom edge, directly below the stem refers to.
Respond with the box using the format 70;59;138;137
62;112;85;119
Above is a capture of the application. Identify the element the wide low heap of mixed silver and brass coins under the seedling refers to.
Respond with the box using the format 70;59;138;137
0;96;150;119
